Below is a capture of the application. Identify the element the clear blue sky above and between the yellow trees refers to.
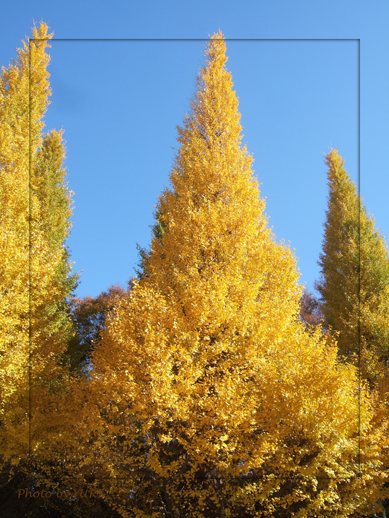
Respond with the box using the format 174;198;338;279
0;0;389;296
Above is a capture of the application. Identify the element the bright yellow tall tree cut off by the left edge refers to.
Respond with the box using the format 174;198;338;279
0;23;75;476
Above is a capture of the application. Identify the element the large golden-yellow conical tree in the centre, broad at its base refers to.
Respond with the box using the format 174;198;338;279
41;33;382;518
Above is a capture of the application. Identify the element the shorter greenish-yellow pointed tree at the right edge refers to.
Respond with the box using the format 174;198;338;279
317;150;389;379
